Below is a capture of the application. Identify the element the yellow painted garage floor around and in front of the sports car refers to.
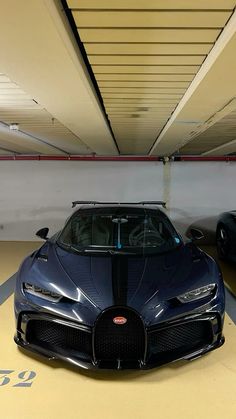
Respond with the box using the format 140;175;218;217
0;243;236;419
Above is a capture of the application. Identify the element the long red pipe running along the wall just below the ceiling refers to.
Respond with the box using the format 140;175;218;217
0;154;236;162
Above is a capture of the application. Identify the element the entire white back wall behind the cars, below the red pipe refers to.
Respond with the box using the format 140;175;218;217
0;161;236;240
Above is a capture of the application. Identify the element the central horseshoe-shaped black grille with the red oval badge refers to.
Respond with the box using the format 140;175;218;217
94;308;145;361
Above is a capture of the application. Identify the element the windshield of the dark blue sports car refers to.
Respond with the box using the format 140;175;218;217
58;208;181;254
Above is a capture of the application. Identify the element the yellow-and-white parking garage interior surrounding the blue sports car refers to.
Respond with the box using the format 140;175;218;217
0;0;236;419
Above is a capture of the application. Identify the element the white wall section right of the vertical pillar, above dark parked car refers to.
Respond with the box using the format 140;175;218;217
169;162;236;242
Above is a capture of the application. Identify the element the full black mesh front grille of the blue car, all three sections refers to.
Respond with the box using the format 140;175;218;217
26;316;213;368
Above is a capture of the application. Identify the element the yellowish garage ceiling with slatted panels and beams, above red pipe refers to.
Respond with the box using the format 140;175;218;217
0;0;236;156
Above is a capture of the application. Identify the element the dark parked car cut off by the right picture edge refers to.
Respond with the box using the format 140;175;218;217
216;211;236;262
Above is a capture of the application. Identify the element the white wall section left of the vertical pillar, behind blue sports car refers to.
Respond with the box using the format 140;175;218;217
0;161;162;240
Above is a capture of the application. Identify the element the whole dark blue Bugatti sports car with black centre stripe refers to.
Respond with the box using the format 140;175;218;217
15;201;225;369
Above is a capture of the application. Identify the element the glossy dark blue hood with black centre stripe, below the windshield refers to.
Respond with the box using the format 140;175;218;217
20;242;215;324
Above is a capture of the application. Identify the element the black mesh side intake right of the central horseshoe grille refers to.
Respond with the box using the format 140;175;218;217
148;321;213;357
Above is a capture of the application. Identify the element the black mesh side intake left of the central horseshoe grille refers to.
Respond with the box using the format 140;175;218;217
26;320;92;358
